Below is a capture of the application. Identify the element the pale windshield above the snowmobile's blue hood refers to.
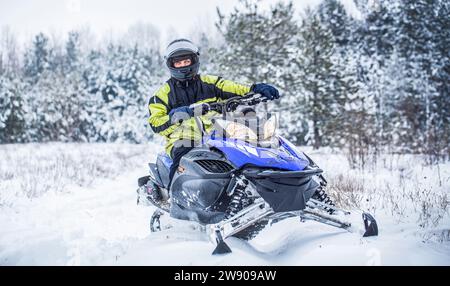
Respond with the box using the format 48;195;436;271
213;114;278;143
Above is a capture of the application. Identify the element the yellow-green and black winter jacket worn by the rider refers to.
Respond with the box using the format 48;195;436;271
148;75;250;155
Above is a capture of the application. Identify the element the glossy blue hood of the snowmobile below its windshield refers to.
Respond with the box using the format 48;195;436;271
206;137;309;171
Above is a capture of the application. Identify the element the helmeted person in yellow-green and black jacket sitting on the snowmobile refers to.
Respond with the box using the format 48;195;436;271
141;39;280;204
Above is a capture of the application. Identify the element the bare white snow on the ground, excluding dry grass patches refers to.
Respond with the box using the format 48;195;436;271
0;143;450;265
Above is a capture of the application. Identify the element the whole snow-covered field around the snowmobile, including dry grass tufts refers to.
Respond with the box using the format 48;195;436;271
0;143;450;265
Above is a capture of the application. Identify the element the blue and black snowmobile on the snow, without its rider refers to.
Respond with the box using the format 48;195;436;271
138;93;378;254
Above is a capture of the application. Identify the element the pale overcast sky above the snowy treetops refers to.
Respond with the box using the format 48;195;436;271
0;0;358;45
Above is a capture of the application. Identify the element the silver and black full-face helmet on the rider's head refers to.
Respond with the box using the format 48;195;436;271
164;39;200;81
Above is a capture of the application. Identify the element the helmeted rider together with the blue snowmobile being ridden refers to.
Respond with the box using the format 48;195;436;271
137;39;378;254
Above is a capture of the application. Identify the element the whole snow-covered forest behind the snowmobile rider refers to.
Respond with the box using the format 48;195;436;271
0;0;450;167
